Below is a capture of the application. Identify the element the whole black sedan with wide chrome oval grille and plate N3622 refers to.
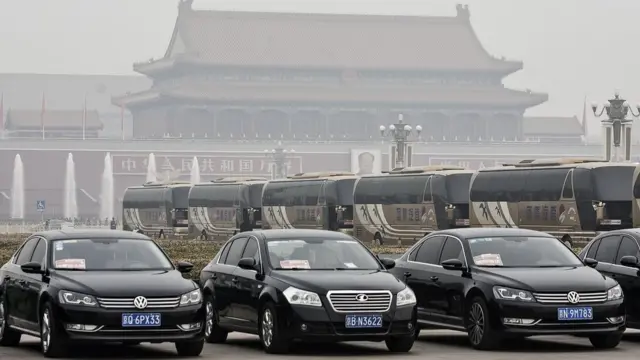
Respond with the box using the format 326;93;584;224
200;229;416;353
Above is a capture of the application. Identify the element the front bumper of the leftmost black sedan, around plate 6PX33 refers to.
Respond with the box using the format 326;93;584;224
56;305;205;343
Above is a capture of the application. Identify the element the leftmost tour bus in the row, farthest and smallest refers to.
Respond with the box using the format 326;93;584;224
122;181;191;237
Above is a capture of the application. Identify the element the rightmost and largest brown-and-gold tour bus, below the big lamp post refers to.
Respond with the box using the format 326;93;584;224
470;159;635;246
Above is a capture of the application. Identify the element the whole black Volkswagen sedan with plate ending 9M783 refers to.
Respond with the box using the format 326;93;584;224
391;228;625;349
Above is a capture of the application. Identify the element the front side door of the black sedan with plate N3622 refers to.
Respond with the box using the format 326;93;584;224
233;236;264;329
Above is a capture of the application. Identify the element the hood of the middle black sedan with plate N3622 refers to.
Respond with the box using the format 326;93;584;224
271;270;406;294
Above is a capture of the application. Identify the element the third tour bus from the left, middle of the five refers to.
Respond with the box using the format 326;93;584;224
262;172;358;231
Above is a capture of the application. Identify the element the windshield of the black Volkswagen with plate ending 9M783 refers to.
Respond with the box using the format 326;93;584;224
469;236;583;267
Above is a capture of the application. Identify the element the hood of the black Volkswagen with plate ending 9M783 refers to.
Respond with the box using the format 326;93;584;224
477;266;616;292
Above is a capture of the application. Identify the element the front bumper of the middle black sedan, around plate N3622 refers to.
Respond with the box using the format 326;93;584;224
278;304;417;342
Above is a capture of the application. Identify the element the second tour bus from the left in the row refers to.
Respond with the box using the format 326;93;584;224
189;177;267;241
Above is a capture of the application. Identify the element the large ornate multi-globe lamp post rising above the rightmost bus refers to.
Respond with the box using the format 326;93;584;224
591;92;640;161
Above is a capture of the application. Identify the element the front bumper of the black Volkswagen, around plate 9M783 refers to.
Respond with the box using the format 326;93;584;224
493;300;626;335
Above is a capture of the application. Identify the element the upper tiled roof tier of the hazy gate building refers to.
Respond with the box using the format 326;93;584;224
137;5;522;74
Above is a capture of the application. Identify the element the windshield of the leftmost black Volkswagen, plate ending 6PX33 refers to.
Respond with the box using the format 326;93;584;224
51;238;173;271
